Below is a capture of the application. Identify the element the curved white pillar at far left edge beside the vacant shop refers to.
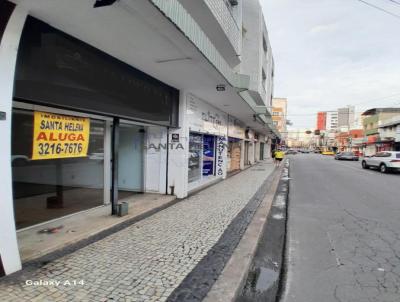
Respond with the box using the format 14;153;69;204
0;6;27;274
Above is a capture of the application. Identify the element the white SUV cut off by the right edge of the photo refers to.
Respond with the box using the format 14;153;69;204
361;151;400;173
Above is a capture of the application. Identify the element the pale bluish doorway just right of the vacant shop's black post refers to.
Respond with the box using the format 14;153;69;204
118;124;145;199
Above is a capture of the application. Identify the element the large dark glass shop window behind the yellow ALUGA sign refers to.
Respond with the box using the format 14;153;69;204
11;109;105;229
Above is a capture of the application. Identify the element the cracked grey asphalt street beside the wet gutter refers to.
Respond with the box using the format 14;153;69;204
281;154;400;302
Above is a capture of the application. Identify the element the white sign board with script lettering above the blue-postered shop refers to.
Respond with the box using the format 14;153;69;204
186;94;228;136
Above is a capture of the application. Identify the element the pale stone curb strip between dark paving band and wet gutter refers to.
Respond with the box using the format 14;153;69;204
203;166;283;302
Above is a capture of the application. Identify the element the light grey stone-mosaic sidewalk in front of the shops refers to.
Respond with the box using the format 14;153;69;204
0;162;274;302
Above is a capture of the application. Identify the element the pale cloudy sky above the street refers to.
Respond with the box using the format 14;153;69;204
260;0;400;128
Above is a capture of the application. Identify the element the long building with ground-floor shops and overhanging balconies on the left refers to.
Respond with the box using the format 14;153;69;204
0;0;279;277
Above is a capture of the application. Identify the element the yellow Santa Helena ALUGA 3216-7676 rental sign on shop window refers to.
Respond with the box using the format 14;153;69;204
32;111;90;160
